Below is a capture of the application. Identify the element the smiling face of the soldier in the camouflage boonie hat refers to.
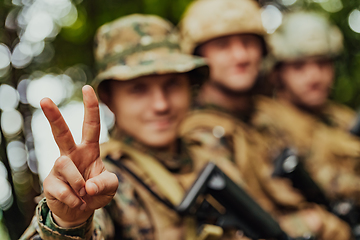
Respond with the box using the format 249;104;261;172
108;74;190;148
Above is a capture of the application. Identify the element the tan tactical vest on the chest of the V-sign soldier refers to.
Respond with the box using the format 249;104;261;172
101;139;249;240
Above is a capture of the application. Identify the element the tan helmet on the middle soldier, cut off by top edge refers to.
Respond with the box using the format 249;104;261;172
179;0;265;54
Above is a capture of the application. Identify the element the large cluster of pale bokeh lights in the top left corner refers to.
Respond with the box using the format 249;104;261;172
5;0;78;71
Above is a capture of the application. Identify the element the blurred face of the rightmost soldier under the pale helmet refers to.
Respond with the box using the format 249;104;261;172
279;58;334;109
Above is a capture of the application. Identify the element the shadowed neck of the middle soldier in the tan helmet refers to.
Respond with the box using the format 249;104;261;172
198;81;253;115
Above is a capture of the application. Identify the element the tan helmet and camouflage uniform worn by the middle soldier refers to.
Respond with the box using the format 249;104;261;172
180;0;350;239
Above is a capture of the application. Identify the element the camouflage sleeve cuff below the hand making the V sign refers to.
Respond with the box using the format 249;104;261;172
20;198;110;240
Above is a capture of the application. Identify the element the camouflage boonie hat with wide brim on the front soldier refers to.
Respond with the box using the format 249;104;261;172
93;14;206;89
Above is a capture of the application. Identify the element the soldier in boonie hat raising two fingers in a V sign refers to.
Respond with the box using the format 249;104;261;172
21;14;262;240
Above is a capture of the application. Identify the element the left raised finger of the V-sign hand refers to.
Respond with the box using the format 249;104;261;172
40;98;76;155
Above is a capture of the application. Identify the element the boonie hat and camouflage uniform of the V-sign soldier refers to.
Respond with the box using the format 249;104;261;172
21;14;250;240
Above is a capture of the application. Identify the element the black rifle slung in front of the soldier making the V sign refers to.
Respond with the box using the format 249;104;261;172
176;162;311;240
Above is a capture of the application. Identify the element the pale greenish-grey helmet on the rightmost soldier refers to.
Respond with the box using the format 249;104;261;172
267;11;343;62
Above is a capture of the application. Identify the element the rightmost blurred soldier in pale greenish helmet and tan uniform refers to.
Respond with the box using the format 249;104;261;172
254;12;360;203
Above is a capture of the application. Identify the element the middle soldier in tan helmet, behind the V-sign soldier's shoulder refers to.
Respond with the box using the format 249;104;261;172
180;0;349;239
